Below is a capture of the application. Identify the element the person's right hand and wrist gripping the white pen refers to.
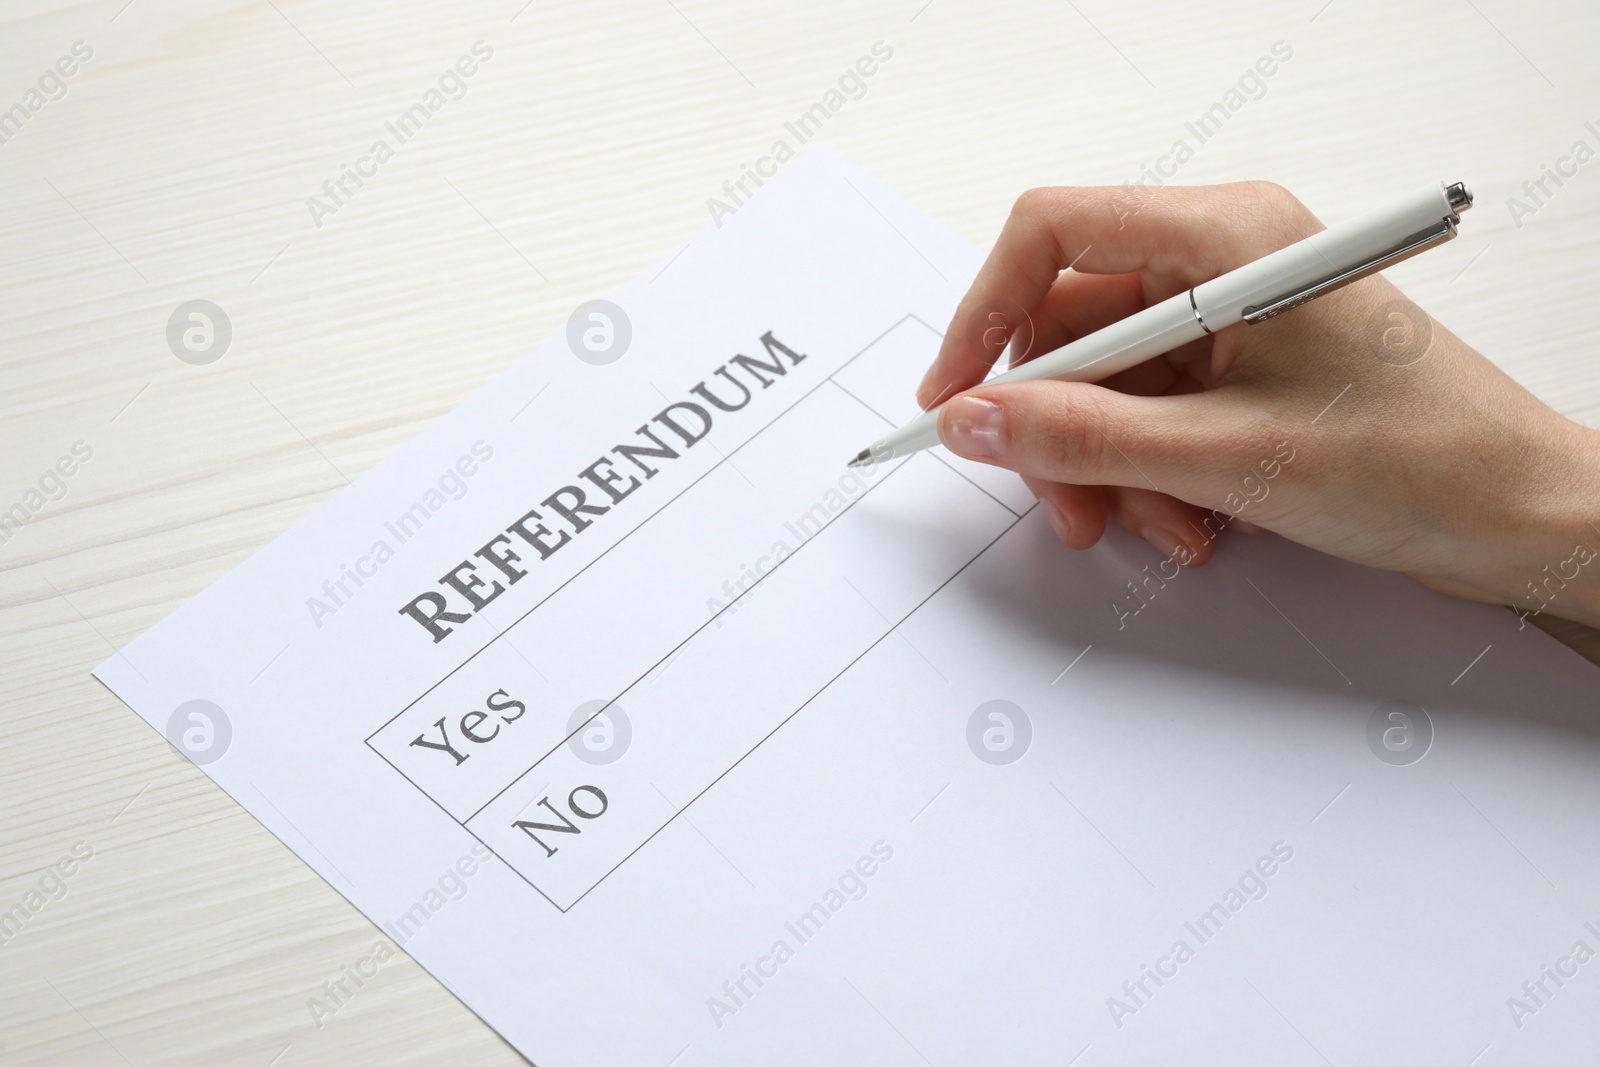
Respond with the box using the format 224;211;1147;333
917;182;1600;625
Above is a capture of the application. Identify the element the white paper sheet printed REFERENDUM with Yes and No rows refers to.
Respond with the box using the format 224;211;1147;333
96;149;1600;1067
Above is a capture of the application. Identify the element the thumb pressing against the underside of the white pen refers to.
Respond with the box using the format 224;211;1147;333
939;381;1259;507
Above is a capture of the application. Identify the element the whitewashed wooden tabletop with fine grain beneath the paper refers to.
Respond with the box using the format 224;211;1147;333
0;0;1600;1067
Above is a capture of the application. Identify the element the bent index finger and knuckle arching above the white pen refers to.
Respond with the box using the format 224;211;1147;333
917;182;1317;408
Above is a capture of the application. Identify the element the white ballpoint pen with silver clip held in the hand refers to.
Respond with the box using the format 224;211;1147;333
850;182;1472;467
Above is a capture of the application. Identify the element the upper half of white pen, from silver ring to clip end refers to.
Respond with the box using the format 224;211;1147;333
1194;182;1456;333
